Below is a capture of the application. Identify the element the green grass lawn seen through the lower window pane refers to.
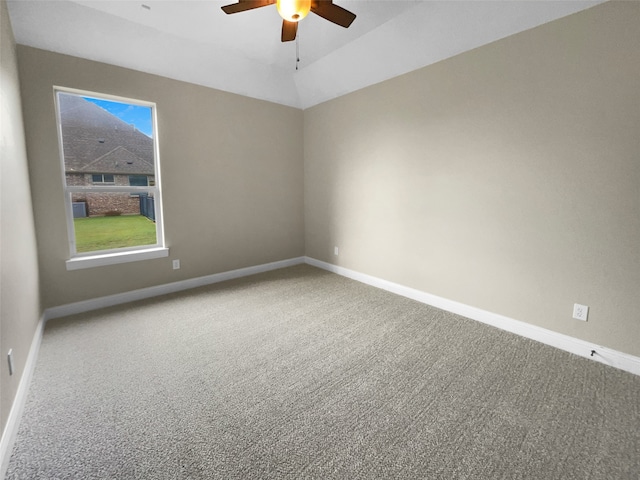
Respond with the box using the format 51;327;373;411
73;215;156;253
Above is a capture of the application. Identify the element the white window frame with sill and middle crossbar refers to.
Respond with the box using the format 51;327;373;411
53;86;169;270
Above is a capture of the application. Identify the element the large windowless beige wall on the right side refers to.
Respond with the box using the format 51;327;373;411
304;2;640;355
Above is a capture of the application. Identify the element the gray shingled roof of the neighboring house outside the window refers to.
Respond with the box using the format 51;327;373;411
59;93;154;175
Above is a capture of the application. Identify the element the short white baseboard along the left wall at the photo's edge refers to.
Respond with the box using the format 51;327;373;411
0;315;45;478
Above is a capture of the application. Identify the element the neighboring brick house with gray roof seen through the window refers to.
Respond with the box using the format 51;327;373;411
58;93;155;216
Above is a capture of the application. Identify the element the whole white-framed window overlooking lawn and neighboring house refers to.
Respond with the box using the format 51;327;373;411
55;88;169;270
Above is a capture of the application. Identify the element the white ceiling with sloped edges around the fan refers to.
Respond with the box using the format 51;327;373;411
7;0;604;108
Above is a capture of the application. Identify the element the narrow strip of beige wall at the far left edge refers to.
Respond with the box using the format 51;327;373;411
0;0;40;432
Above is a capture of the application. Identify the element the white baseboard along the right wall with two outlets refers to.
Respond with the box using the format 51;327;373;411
305;257;640;375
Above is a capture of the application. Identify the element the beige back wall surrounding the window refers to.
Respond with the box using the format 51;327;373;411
18;46;304;308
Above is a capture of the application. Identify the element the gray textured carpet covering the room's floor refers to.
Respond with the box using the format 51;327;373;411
7;265;640;480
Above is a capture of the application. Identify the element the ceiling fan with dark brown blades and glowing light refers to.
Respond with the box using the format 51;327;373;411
222;0;356;42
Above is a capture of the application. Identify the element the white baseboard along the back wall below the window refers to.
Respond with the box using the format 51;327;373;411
44;257;305;320
